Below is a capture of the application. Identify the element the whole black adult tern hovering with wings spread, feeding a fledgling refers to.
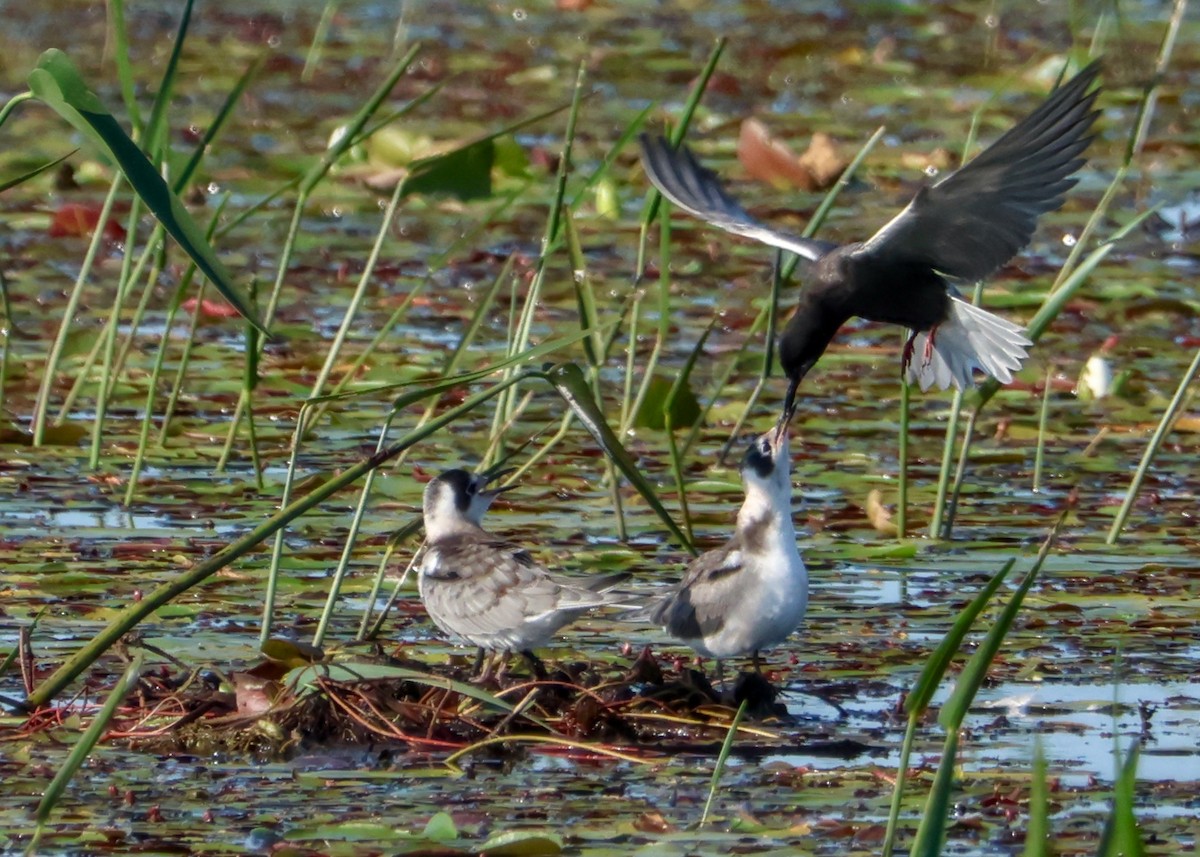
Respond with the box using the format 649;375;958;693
642;61;1100;425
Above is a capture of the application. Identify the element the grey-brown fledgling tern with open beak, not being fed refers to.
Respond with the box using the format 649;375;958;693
418;469;628;678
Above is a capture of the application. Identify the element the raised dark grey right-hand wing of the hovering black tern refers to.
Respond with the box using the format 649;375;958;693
858;61;1099;281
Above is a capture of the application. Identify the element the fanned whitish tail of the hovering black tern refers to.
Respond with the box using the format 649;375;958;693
907;296;1033;390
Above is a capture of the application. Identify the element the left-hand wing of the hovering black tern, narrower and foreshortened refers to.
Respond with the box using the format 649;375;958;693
641;134;838;260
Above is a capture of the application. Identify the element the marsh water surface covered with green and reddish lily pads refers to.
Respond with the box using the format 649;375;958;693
0;0;1200;855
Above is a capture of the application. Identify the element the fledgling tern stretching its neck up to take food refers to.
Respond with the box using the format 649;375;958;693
650;426;809;681
